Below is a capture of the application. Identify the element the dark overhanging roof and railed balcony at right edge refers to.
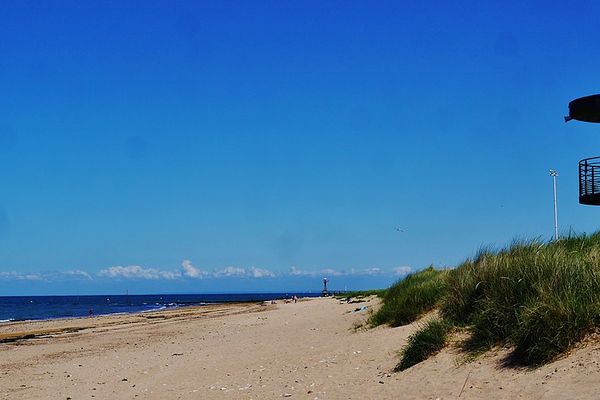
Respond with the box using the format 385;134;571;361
565;94;600;206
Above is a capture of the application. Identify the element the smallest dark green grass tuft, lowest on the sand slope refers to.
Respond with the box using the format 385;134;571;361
396;317;452;371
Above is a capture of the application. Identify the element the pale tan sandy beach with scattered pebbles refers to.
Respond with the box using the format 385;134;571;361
0;299;600;400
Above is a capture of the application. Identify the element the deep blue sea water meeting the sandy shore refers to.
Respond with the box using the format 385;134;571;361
0;293;319;323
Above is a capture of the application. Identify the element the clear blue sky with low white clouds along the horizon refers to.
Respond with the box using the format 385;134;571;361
0;1;600;294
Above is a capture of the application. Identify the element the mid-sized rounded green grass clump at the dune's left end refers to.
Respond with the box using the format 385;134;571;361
370;267;447;326
